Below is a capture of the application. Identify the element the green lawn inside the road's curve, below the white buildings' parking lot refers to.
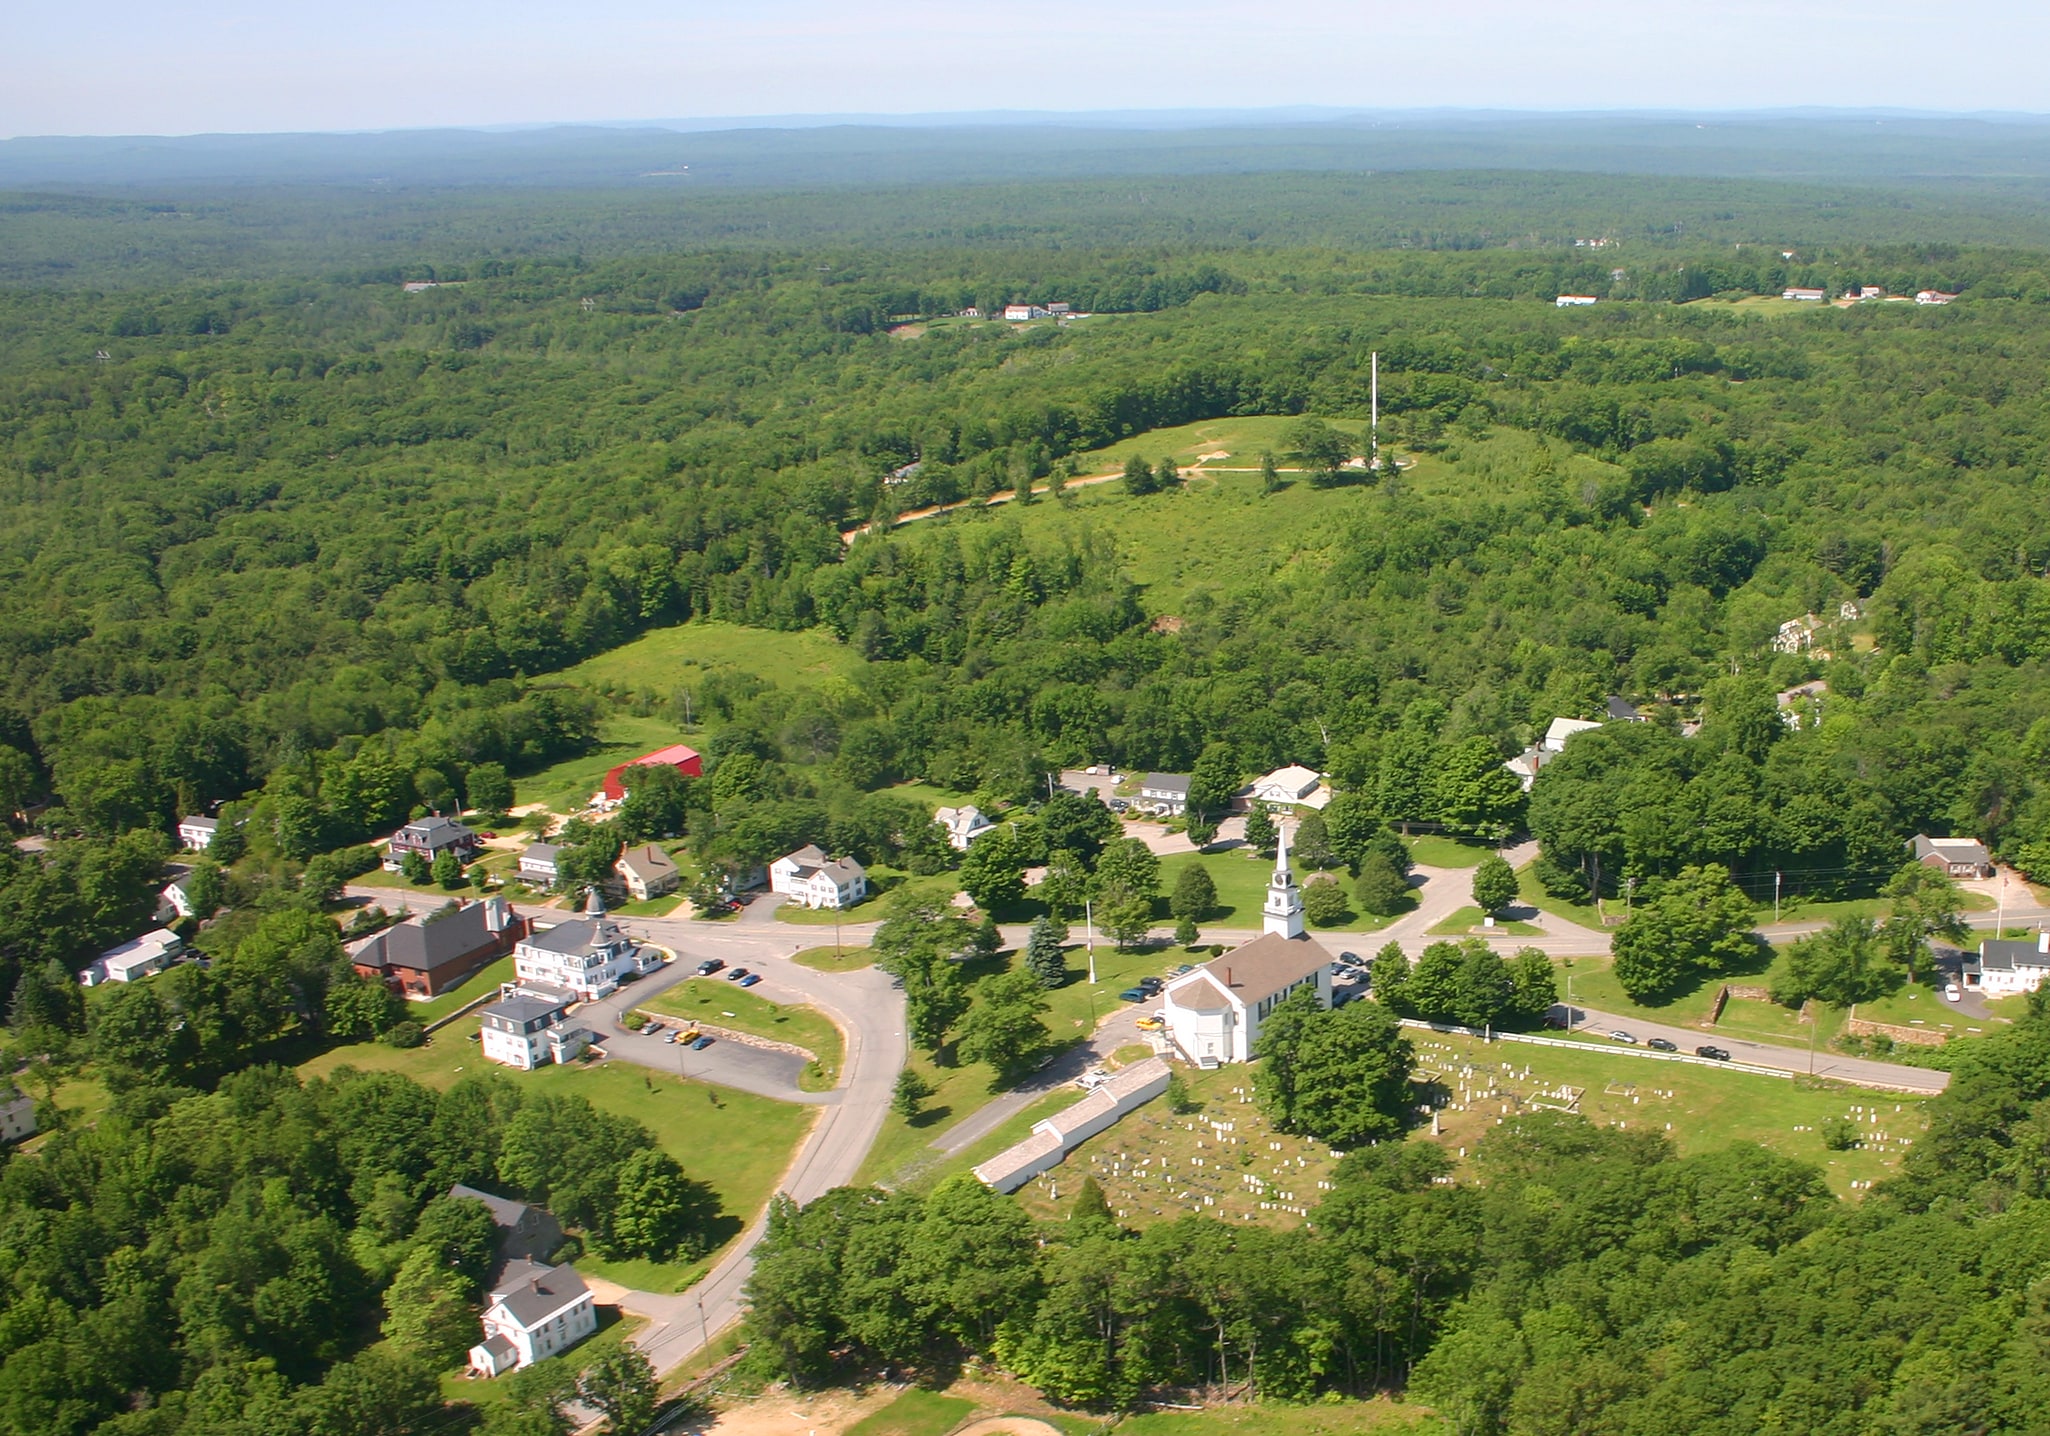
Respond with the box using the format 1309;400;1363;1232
299;1015;818;1290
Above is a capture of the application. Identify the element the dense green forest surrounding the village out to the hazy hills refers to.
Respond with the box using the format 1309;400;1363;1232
0;163;2050;1436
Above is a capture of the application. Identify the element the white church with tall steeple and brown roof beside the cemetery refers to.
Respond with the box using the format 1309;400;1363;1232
1160;831;1333;1069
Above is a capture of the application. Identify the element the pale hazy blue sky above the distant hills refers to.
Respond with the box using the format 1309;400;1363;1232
0;0;2050;135
